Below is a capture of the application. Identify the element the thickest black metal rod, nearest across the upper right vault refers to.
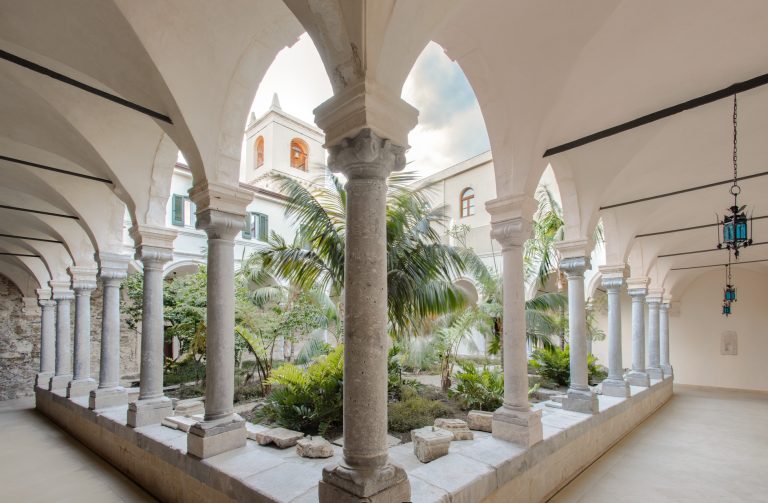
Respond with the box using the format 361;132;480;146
543;73;768;157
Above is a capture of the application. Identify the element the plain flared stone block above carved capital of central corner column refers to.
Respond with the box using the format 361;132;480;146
314;79;419;151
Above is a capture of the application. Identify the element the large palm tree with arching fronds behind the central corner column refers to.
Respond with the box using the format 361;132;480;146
260;173;485;340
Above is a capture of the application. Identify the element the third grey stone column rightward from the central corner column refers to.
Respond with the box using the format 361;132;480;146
600;265;629;397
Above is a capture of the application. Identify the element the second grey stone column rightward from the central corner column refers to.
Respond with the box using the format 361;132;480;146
557;241;600;414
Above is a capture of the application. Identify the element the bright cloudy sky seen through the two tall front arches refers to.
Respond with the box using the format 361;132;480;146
251;33;490;176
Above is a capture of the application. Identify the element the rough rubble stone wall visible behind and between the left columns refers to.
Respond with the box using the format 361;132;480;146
0;275;141;400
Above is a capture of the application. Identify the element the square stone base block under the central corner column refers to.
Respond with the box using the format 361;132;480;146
318;463;411;503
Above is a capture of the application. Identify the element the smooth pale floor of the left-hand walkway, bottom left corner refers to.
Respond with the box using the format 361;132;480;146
0;397;156;503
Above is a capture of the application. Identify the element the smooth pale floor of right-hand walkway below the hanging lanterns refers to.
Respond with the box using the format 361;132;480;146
550;385;768;503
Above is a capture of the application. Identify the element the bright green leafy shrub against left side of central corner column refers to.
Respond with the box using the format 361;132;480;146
257;346;344;435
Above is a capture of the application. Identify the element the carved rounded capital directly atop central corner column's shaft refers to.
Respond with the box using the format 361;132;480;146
328;128;405;180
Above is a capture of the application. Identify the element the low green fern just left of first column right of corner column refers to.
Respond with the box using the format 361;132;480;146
451;361;504;411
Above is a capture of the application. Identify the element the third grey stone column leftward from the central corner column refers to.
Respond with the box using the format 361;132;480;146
88;253;129;409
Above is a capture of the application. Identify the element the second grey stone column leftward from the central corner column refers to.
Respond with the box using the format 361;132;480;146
128;227;176;428
